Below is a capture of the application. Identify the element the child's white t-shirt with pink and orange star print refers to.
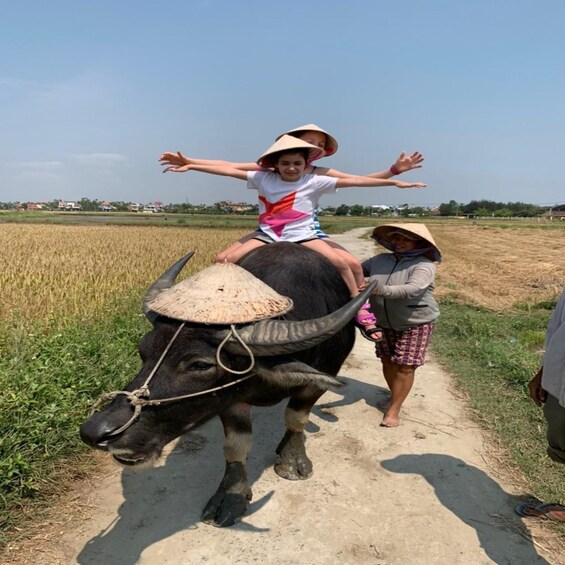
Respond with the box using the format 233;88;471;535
247;171;337;241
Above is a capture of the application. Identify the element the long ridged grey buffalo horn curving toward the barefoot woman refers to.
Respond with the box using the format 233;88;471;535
222;281;377;355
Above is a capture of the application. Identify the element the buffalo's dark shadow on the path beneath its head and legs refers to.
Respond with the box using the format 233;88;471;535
76;402;286;565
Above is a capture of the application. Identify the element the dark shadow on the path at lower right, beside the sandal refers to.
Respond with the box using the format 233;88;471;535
381;453;549;565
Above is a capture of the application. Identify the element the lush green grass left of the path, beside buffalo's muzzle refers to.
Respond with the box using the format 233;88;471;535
0;300;149;546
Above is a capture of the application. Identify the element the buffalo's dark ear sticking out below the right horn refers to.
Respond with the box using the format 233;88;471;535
257;357;343;389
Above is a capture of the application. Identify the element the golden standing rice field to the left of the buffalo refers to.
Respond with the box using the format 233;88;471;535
0;224;248;322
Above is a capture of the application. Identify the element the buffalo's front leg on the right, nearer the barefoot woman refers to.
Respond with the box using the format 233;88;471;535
275;388;324;481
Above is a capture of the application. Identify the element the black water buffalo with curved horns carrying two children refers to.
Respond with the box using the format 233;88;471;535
80;243;372;526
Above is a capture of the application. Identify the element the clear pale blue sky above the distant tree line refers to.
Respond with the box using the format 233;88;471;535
0;0;565;206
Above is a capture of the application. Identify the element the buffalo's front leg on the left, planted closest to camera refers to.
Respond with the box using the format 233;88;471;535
202;403;252;527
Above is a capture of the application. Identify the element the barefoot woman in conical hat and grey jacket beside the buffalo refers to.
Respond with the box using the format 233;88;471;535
363;223;441;428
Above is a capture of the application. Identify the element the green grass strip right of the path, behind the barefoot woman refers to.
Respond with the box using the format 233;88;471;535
432;301;565;512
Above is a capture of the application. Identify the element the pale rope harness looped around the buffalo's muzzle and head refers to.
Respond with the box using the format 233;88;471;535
90;322;255;436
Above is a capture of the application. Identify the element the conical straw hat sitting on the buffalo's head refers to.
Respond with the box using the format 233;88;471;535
148;263;293;325
